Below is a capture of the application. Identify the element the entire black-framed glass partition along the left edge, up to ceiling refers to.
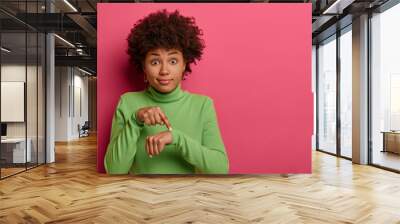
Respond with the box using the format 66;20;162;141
0;1;46;179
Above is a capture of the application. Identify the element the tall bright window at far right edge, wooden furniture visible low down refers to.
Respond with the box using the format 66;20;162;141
371;4;400;170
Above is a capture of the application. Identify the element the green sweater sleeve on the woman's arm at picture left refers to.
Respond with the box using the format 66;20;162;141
104;97;141;174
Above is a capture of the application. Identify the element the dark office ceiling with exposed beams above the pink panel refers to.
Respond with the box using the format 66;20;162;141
0;0;394;75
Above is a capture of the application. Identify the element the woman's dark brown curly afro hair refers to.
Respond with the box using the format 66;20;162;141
127;9;205;75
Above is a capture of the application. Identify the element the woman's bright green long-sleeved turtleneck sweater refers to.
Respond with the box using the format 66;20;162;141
104;85;229;174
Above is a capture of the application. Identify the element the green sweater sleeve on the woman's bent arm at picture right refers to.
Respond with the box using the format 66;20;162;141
172;99;229;174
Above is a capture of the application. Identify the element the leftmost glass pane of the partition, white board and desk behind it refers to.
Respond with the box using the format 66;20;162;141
0;32;27;177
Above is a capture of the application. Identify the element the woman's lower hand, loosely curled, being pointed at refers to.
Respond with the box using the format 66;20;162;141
145;131;172;157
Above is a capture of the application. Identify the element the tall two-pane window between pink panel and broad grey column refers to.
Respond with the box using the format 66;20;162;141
317;25;352;158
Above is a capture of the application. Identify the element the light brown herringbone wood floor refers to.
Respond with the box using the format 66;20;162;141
0;134;400;224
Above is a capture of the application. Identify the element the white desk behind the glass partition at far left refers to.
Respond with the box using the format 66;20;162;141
1;138;32;163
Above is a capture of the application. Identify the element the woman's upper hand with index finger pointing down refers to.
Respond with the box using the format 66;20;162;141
136;106;172;130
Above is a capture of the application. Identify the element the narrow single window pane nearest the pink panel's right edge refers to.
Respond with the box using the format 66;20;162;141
317;36;336;153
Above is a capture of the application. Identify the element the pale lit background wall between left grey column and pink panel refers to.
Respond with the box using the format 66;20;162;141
55;67;88;141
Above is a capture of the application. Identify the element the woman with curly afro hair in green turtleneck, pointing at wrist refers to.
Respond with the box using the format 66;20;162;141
104;10;229;174
